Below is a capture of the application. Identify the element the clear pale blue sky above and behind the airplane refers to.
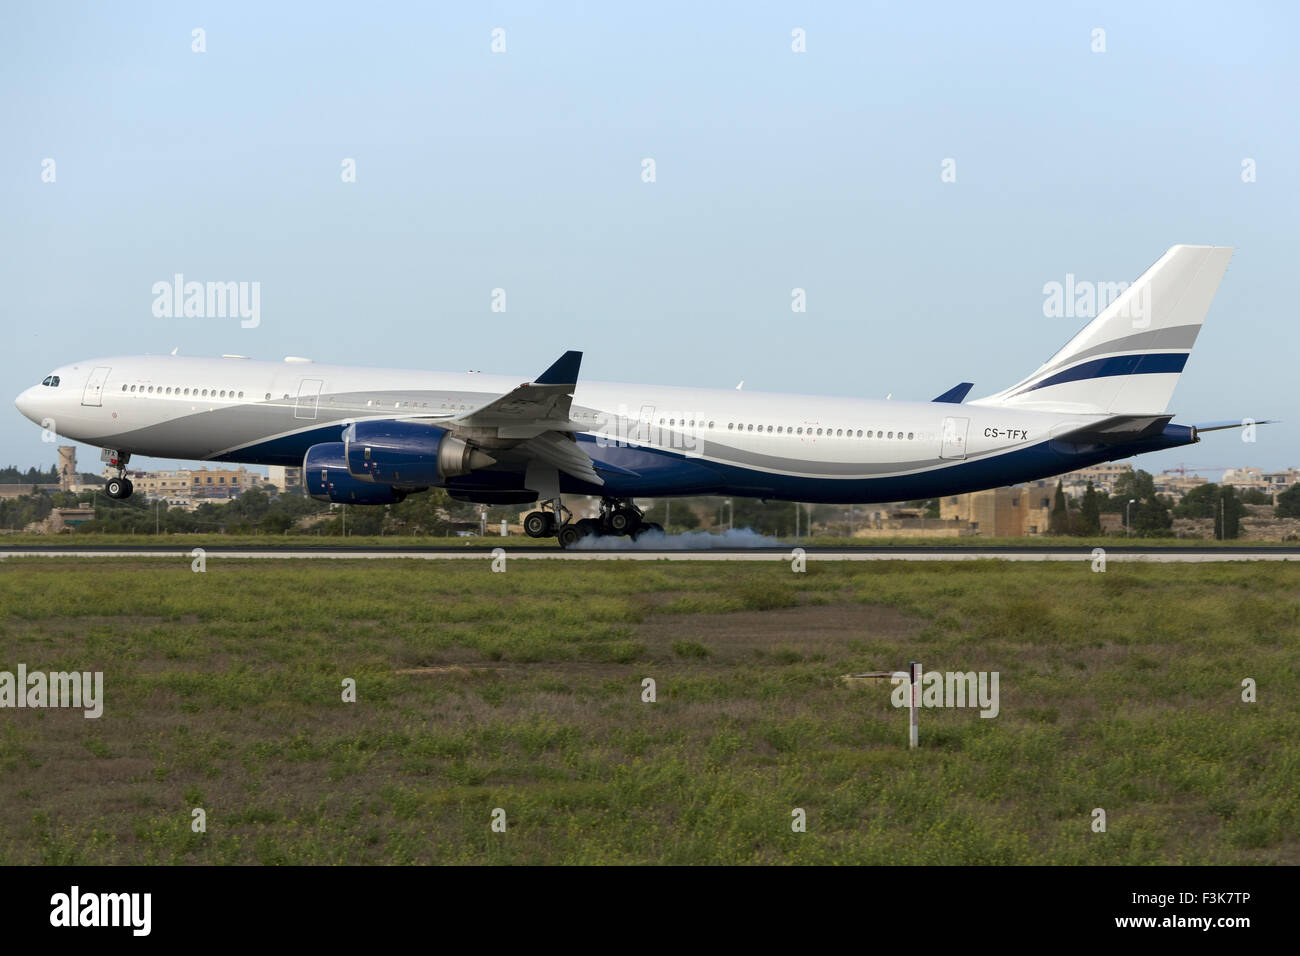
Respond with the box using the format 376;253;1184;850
0;3;1300;471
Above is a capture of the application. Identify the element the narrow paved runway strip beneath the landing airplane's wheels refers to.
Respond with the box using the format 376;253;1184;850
0;544;1300;564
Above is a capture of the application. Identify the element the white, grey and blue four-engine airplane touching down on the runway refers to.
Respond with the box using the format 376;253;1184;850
16;245;1264;548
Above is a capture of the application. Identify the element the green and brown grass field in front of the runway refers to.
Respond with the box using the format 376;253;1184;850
0;557;1300;864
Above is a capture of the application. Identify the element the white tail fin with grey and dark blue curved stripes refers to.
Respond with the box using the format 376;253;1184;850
971;246;1232;415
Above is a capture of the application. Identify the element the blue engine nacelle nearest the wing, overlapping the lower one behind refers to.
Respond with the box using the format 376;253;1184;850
343;419;495;488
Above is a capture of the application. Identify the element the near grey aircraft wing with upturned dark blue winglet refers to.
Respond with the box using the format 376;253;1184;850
450;350;605;485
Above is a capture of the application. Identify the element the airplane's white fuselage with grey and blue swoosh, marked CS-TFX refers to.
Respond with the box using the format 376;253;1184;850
16;356;1138;502
